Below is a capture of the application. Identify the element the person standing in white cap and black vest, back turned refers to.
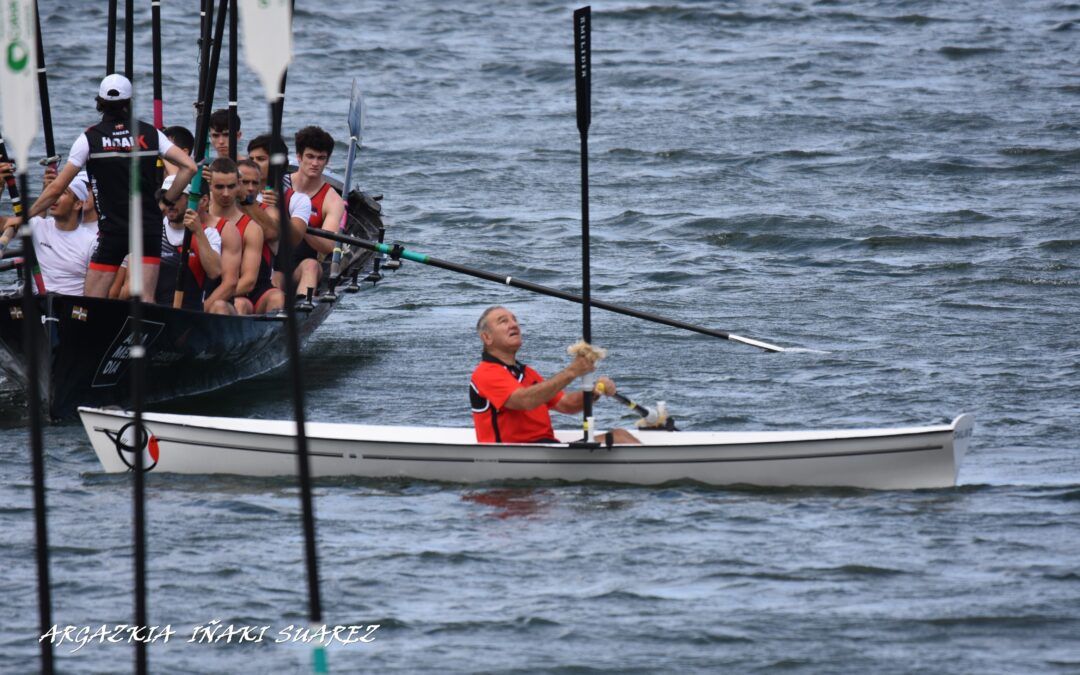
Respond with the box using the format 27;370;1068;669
29;73;195;302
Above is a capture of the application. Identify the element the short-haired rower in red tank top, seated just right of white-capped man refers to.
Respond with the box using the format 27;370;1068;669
203;157;251;314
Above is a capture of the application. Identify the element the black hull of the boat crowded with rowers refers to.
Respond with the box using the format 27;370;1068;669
0;294;335;419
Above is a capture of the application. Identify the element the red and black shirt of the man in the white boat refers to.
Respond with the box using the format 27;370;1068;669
469;352;563;443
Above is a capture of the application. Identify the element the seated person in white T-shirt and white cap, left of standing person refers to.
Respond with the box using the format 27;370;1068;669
0;172;97;295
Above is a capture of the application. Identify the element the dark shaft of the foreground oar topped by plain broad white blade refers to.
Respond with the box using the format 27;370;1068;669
270;102;323;624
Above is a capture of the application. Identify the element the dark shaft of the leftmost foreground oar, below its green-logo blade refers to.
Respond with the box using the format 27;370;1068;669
18;170;53;673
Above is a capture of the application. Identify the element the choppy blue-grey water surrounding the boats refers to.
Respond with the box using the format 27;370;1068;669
0;0;1080;673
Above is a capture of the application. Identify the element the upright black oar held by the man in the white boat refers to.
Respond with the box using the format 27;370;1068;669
573;6;594;443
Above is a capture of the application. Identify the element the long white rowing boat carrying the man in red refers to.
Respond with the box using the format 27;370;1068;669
79;407;974;489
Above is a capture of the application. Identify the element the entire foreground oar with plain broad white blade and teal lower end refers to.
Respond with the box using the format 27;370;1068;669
240;0;327;673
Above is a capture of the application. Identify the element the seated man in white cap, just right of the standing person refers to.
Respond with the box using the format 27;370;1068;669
156;176;221;312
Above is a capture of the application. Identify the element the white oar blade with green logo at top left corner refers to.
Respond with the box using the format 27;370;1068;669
0;0;39;171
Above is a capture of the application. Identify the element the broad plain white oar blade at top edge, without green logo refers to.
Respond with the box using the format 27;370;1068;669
240;0;293;103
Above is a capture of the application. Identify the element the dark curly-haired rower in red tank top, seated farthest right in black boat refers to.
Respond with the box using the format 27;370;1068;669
289;126;345;296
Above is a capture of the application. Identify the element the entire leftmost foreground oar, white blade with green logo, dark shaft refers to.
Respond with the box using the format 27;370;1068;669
0;0;53;674
